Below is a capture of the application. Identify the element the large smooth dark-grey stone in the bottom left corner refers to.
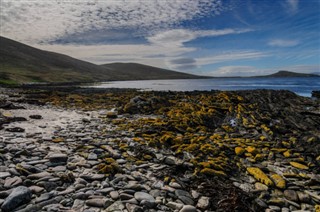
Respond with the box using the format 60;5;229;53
1;186;32;212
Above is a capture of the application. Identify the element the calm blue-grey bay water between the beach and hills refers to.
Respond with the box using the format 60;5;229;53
90;77;320;97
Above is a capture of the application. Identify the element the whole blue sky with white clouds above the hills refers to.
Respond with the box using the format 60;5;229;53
0;0;320;76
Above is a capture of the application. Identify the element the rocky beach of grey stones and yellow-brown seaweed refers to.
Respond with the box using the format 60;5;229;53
0;86;320;212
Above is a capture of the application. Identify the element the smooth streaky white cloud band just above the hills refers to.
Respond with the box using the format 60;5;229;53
34;29;252;69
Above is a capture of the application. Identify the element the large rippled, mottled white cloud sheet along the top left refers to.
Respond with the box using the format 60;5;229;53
0;0;221;43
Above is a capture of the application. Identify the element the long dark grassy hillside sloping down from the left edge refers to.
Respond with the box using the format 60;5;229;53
0;36;203;84
